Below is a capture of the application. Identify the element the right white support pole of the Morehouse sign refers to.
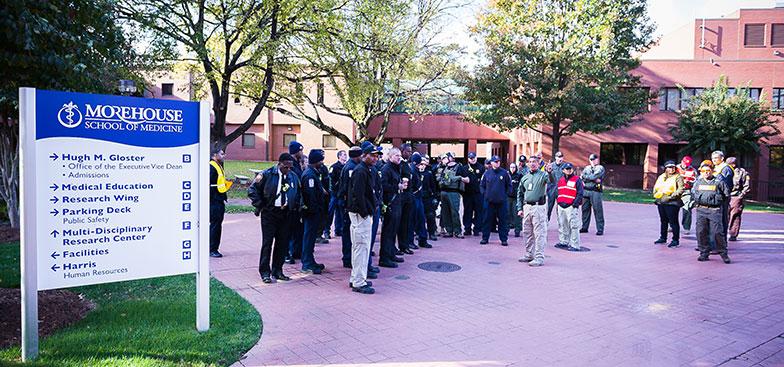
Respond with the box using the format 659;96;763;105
196;101;210;332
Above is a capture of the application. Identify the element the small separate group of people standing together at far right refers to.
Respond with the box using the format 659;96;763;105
653;150;751;264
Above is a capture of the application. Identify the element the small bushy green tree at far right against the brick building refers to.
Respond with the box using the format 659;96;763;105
670;76;781;156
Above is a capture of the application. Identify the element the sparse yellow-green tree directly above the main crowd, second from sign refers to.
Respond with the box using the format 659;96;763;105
275;0;459;145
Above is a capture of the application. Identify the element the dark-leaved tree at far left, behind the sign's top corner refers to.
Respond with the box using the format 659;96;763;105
0;0;147;228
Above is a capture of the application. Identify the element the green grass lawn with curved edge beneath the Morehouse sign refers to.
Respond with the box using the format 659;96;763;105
0;244;261;367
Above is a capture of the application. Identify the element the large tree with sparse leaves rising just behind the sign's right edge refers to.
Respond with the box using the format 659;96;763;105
117;0;341;147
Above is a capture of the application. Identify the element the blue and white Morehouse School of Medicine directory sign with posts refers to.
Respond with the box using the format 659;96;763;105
19;88;209;360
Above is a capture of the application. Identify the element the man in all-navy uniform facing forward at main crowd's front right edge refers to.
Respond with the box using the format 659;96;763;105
479;155;512;246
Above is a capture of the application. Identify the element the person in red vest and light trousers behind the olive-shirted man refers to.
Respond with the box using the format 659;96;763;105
555;162;585;251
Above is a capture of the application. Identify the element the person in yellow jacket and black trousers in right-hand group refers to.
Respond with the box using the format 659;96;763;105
653;161;684;248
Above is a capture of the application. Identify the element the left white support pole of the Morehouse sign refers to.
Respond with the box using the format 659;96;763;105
19;88;38;362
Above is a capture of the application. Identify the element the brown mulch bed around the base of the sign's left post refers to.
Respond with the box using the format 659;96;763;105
0;288;95;348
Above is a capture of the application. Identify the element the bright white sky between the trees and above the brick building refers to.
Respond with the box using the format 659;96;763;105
438;0;782;68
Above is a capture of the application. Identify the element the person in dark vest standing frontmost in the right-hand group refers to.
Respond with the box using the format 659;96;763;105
691;160;731;264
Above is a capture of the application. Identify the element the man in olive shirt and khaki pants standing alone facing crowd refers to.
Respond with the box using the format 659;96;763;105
517;155;554;266
